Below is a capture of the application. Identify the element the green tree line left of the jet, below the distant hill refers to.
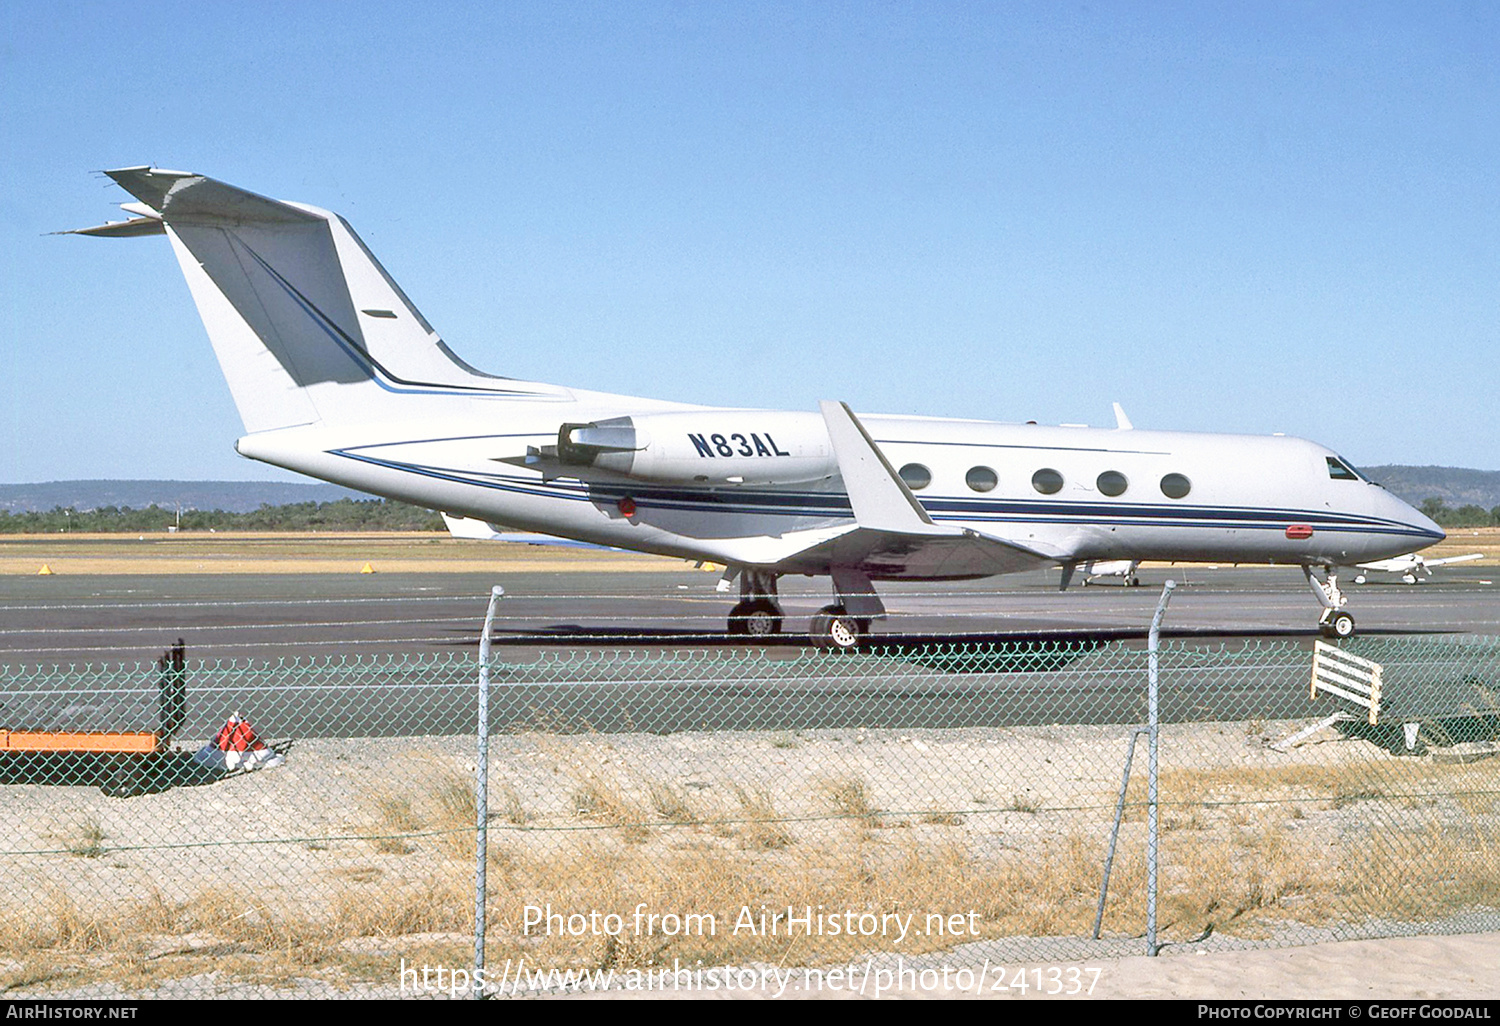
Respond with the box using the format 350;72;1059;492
0;498;444;534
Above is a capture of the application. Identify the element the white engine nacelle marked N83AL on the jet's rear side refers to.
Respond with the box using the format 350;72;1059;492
549;410;839;485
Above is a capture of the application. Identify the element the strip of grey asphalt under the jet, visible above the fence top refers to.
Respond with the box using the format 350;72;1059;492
0;567;1500;666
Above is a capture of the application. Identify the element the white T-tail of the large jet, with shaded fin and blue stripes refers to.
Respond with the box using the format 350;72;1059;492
69;167;569;432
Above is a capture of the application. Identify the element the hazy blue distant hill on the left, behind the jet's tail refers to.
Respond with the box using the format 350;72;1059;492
0;482;369;513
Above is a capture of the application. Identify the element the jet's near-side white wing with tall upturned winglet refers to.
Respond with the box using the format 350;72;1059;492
750;401;1070;579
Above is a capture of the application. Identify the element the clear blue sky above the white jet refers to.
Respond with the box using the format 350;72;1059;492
0;2;1500;482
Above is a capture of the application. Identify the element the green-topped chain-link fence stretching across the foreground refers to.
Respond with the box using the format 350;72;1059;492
0;621;1500;996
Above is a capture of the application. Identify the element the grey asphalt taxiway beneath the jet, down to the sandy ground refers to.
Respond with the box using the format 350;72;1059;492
0;567;1500;738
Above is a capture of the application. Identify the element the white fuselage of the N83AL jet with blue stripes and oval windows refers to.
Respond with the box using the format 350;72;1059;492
239;398;1443;579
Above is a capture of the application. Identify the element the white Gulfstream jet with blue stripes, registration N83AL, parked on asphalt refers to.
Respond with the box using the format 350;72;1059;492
77;167;1443;647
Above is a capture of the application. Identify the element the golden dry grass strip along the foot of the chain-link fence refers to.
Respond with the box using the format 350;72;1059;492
0;804;1500;986
